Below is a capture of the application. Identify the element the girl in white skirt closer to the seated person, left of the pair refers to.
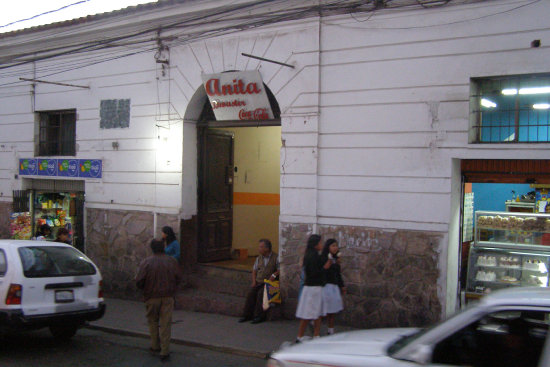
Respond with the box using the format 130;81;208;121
296;234;331;343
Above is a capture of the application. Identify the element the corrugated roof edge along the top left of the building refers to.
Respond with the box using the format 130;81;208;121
0;0;194;39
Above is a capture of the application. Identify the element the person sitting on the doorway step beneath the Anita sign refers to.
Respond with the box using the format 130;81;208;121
239;238;279;324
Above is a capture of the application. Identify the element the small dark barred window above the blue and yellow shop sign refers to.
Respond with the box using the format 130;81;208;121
38;110;76;156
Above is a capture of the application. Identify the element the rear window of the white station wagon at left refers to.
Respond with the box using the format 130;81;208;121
19;246;96;278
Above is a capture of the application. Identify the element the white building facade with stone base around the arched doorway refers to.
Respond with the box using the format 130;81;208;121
0;0;550;327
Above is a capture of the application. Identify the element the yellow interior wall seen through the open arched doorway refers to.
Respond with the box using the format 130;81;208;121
220;126;281;256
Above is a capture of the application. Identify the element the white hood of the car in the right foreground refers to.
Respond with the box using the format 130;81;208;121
274;328;418;359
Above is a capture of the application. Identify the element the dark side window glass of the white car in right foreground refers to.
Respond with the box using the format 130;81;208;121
432;310;549;367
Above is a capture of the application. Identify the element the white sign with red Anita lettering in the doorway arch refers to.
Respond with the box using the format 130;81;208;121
202;70;274;121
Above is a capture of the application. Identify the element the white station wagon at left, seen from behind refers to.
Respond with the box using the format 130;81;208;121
0;240;105;339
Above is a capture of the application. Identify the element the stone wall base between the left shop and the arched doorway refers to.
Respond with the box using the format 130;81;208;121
86;208;179;299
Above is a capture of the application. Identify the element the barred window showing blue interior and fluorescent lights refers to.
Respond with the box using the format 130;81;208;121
469;74;550;143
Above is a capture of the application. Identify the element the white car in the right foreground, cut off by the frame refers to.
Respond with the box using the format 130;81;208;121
267;288;550;367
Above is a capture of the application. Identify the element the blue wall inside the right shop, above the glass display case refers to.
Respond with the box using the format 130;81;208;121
472;183;533;213
